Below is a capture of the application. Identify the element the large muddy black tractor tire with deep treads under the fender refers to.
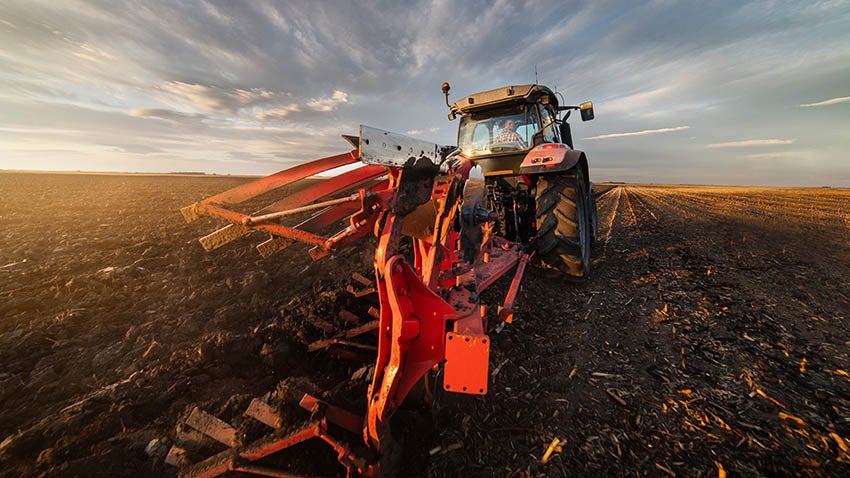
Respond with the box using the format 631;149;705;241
535;168;592;280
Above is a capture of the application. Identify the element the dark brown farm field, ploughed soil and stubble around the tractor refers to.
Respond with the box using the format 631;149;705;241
0;173;850;477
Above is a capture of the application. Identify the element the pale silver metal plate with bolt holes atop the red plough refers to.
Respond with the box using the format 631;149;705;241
360;125;444;168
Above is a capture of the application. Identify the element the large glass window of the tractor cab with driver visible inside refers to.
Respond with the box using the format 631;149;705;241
458;105;540;158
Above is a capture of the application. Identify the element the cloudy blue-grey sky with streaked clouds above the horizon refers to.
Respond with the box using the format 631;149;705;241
0;0;850;187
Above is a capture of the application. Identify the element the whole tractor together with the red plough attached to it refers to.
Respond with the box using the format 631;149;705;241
172;83;596;477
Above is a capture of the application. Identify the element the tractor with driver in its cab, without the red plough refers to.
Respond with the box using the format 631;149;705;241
443;83;597;280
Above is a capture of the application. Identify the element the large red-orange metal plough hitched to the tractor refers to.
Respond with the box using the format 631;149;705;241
175;126;530;477
